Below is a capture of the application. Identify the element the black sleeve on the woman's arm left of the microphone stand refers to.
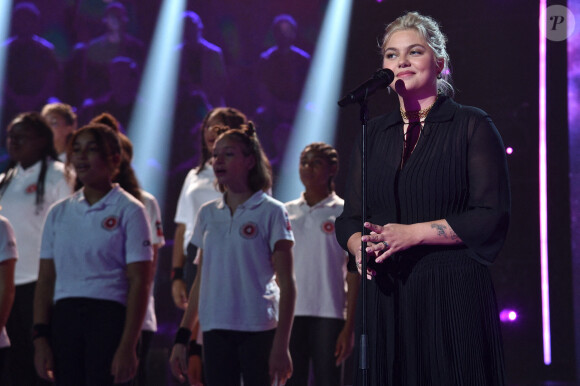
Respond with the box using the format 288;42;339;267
335;130;362;272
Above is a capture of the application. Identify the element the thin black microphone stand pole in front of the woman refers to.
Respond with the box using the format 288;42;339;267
359;94;369;386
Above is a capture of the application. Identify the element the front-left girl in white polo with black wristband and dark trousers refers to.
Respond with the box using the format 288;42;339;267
33;124;152;385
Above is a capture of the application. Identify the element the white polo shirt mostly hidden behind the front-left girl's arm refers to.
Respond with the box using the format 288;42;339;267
141;190;165;331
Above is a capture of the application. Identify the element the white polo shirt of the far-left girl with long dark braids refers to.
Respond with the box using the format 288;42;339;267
0;160;72;285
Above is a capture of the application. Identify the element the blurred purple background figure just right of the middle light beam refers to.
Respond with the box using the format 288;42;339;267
178;11;227;107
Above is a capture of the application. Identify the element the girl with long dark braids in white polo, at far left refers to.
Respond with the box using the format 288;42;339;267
0;112;72;385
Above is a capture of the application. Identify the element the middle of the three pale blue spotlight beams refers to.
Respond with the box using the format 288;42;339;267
128;0;186;210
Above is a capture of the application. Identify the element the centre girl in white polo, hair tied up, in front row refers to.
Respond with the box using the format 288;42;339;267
170;123;296;386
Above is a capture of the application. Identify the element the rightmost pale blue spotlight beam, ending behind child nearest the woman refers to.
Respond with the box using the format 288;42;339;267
274;0;352;202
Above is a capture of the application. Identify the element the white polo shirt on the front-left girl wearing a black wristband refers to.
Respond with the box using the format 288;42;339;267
40;184;153;305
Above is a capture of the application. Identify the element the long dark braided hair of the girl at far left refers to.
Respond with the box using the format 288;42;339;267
0;111;58;213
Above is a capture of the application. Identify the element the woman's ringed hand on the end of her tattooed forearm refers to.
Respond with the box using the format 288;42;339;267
362;222;420;263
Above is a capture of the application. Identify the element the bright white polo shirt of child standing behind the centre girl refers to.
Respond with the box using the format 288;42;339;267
175;162;222;251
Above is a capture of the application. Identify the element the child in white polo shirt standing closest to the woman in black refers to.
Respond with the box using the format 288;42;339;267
286;142;360;386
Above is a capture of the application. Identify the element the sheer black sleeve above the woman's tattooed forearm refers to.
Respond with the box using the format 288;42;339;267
446;111;510;264
